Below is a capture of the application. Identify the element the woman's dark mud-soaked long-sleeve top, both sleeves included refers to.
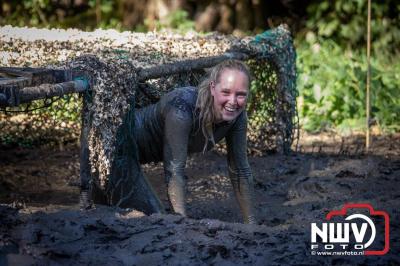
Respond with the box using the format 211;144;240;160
135;87;255;223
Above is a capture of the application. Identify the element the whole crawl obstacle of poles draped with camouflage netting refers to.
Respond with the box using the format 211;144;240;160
0;26;298;213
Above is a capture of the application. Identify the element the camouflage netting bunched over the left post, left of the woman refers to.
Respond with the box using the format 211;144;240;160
67;56;138;187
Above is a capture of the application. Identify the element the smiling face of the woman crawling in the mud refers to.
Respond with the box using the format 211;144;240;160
211;69;249;122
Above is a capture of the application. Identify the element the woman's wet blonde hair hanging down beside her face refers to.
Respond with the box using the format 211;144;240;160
196;59;251;153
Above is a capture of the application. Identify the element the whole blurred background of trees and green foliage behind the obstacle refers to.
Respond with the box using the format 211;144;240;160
0;0;400;143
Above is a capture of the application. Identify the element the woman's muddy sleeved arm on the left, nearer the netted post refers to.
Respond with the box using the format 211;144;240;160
163;108;192;216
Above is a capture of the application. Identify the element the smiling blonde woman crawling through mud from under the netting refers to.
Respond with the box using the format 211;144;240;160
86;60;256;223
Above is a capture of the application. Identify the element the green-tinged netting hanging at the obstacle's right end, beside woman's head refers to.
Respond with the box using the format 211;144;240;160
250;27;298;153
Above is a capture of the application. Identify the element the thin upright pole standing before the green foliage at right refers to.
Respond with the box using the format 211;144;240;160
365;0;371;151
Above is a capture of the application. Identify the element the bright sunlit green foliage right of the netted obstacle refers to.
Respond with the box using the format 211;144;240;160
296;0;400;131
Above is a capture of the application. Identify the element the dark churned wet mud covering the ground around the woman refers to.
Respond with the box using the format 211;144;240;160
0;134;400;265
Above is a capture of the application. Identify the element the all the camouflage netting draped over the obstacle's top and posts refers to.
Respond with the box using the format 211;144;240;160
0;26;298;208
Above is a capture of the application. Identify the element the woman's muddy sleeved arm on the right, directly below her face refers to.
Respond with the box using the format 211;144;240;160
226;112;257;223
